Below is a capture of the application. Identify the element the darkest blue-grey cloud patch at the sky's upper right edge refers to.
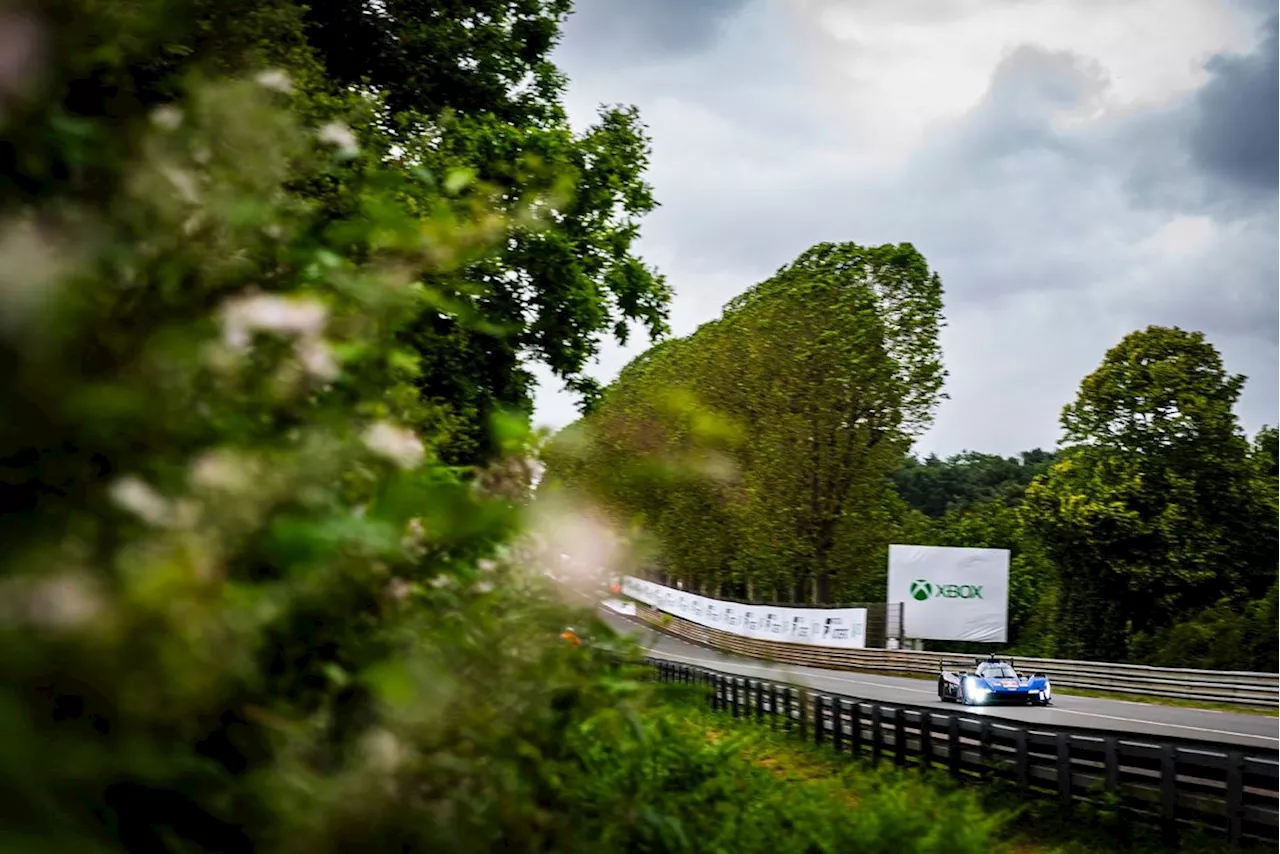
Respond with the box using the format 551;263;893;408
1190;15;1280;191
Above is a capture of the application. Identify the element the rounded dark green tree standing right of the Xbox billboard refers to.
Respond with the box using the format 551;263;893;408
1023;326;1271;659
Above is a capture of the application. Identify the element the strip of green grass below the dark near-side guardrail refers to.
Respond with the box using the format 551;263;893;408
663;686;1275;854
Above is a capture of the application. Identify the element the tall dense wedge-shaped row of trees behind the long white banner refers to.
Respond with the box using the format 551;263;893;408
544;243;943;602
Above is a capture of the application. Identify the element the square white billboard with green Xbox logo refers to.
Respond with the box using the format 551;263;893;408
887;545;1009;644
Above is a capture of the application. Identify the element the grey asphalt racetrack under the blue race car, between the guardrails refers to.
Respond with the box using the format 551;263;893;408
602;612;1280;752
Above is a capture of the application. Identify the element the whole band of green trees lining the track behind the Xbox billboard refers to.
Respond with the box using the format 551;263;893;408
548;261;1280;670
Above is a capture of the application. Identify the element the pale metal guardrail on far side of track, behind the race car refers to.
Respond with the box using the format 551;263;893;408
636;603;1280;708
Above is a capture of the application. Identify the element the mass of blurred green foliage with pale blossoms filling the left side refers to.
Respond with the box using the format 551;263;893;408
0;0;803;853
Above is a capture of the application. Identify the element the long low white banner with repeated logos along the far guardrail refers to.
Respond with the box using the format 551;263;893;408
622;575;867;649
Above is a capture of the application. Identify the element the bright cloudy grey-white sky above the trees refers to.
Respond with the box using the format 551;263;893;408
524;0;1280;455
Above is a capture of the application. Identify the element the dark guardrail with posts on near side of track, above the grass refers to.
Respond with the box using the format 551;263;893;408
646;658;1280;842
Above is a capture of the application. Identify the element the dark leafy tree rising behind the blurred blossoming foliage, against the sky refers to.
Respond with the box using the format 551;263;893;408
293;0;671;463
